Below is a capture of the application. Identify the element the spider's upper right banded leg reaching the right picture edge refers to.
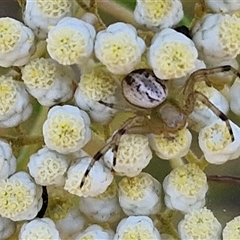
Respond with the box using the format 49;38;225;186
183;65;240;96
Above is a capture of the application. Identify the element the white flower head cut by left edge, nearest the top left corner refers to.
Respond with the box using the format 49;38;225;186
0;17;34;67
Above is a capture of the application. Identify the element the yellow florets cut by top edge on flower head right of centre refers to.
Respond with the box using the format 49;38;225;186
141;0;173;23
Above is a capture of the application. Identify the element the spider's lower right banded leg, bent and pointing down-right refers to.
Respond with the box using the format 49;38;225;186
183;91;234;142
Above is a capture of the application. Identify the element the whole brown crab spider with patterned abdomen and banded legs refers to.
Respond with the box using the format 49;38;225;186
80;65;240;187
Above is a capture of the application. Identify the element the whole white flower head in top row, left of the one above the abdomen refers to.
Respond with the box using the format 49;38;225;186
47;17;96;65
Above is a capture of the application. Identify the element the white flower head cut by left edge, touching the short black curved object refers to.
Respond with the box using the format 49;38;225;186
0;172;42;221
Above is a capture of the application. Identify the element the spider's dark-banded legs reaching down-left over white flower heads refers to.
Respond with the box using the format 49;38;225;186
80;116;146;188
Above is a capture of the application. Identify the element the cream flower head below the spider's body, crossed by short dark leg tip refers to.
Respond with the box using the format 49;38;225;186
103;134;152;177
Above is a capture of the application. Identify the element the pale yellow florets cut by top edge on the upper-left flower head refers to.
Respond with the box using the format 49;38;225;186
36;0;71;18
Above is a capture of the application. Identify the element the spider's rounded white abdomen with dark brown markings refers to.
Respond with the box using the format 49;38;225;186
122;69;168;108
